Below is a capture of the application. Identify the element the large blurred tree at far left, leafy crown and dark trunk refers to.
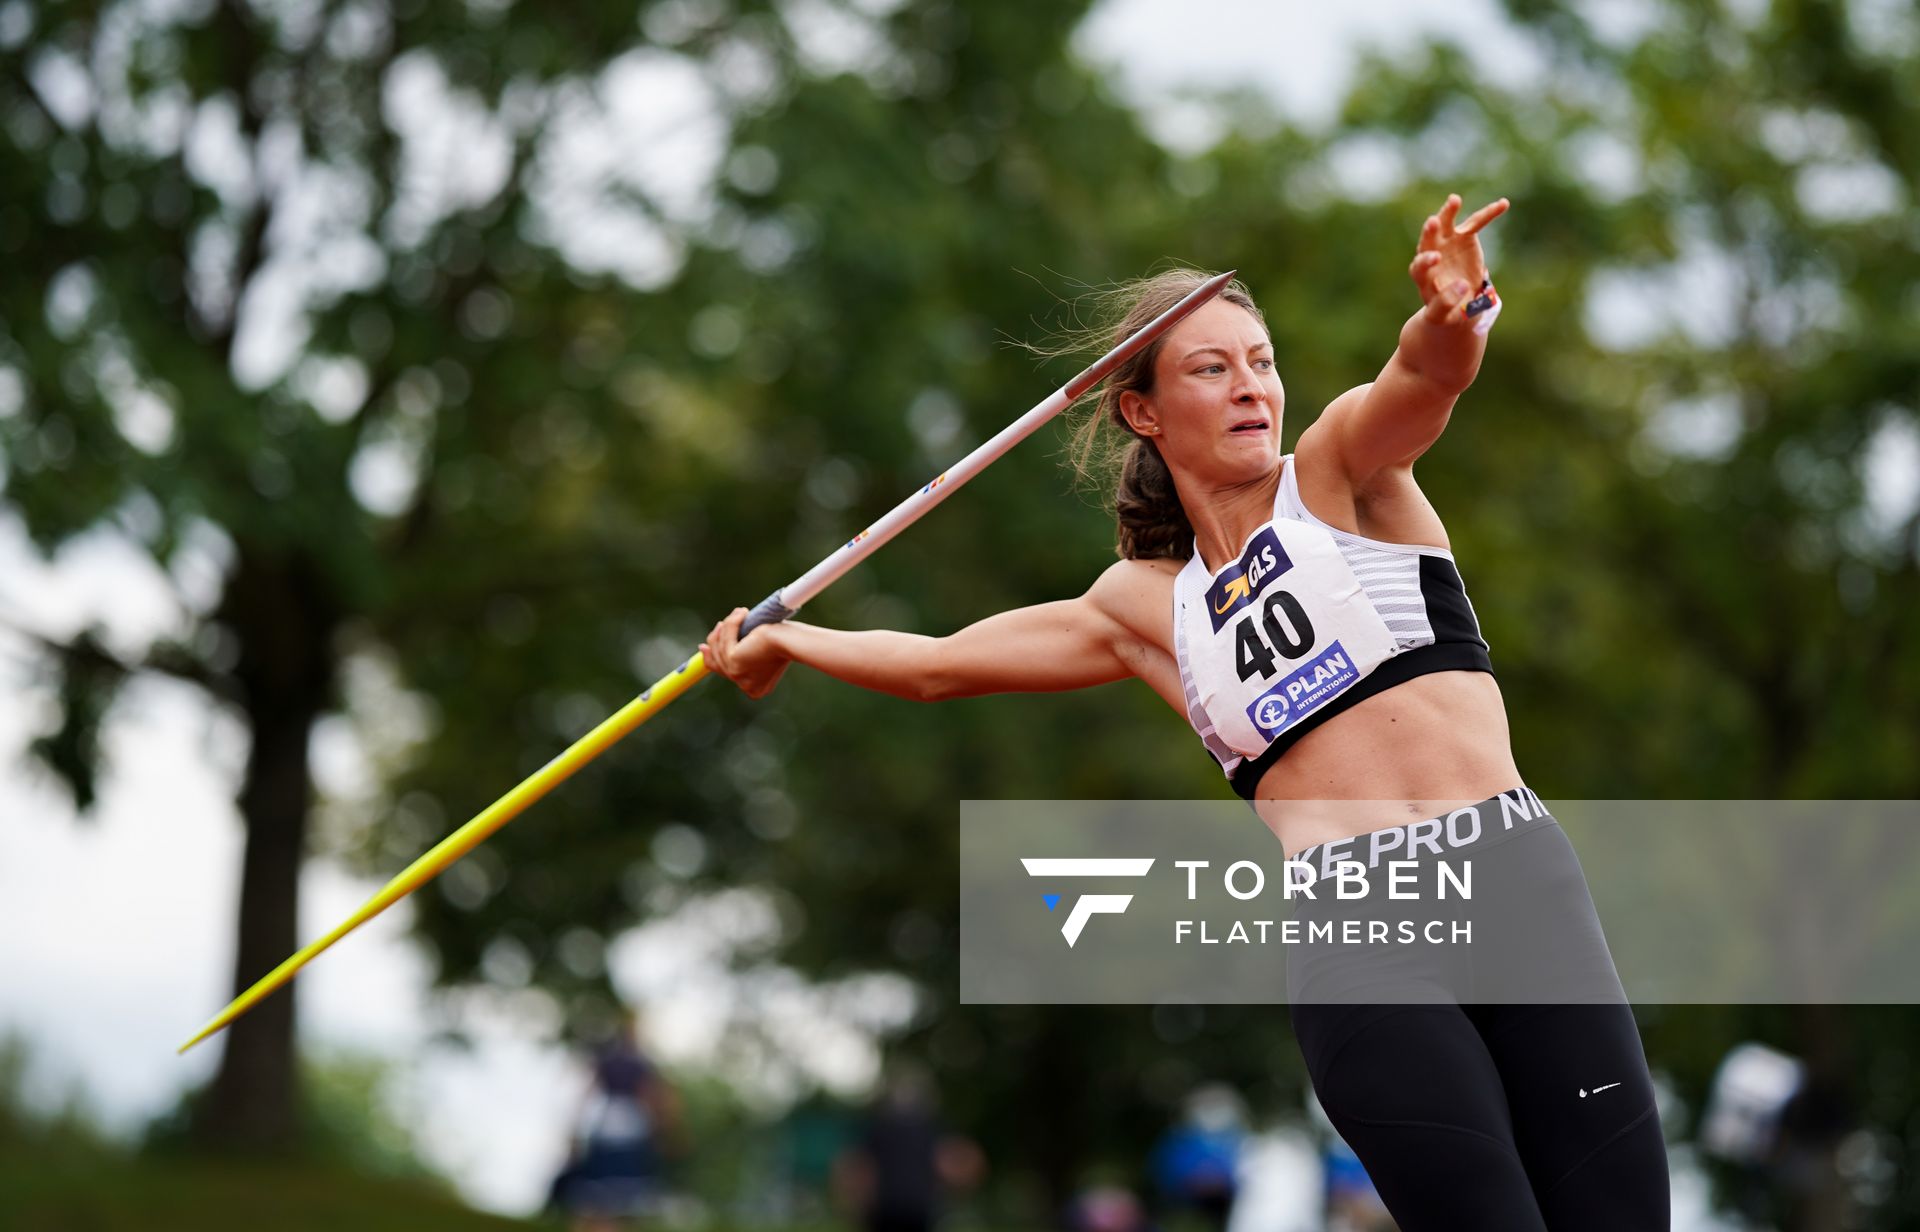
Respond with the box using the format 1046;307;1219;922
0;0;791;1148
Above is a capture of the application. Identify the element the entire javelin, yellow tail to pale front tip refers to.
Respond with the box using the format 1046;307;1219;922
180;271;1236;1052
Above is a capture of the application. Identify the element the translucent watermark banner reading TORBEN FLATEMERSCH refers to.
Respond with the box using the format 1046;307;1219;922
960;789;1920;1004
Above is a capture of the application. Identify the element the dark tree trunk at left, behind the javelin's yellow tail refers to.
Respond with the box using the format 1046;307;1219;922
194;545;338;1153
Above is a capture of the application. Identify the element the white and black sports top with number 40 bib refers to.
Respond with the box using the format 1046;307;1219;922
1173;455;1494;800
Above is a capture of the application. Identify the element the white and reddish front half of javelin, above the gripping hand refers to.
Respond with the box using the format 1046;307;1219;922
739;269;1236;637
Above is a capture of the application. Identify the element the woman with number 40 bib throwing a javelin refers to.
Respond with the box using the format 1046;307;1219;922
701;196;1668;1232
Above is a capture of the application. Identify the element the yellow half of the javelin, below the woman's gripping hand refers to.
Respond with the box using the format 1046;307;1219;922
180;652;707;1052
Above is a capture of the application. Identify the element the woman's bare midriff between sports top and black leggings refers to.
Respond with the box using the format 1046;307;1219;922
1254;672;1521;856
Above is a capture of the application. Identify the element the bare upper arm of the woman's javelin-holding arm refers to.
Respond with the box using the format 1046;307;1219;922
927;595;1133;700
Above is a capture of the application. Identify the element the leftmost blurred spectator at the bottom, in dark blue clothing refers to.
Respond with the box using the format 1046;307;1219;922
549;1009;680;1232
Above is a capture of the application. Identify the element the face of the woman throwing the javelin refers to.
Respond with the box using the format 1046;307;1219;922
1119;299;1286;486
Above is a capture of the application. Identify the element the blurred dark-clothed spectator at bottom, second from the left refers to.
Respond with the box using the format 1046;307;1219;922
835;1063;987;1232
